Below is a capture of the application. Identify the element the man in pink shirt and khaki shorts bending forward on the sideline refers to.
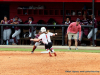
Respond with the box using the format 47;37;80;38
67;18;81;50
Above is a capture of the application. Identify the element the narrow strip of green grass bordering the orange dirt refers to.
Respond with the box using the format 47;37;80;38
0;48;100;53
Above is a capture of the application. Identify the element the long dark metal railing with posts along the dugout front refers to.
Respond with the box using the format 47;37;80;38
0;24;94;46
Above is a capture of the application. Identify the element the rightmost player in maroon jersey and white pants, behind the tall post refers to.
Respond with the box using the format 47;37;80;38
87;15;98;46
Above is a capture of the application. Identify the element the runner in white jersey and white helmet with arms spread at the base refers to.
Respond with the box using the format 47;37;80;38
30;27;57;56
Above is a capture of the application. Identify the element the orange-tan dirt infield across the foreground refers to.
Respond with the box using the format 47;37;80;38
0;51;100;75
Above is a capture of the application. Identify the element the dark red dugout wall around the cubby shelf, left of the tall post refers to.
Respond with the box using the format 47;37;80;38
10;3;63;24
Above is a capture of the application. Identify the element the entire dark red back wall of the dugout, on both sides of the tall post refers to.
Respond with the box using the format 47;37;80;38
10;2;100;24
